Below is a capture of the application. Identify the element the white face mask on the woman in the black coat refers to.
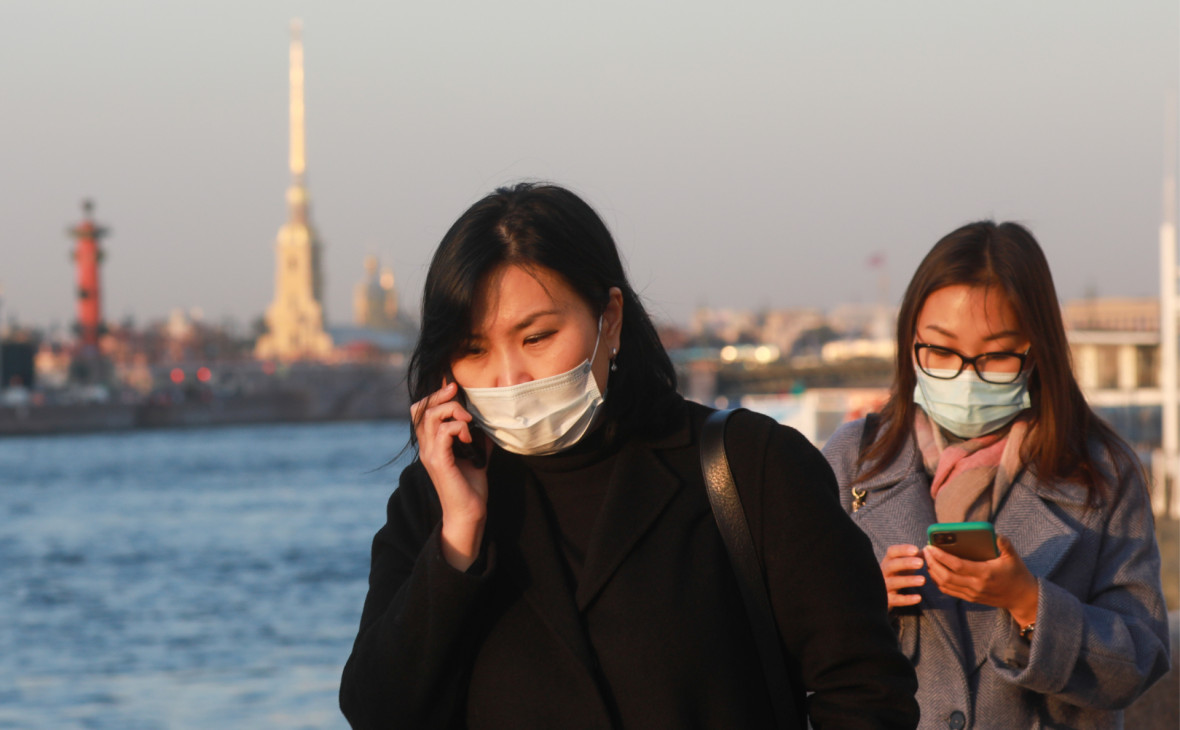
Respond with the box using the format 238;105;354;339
464;317;603;455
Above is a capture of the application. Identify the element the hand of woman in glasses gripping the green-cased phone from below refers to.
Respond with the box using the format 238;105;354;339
924;535;1037;626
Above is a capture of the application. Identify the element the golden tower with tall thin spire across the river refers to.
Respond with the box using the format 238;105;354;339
255;20;332;361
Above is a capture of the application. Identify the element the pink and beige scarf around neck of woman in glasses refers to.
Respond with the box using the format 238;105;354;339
913;408;1029;522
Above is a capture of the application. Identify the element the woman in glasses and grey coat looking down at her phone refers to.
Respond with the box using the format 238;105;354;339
824;222;1168;729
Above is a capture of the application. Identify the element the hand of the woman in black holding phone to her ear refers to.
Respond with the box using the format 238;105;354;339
409;382;491;571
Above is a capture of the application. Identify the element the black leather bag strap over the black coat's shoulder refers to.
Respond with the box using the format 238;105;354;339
701;410;798;728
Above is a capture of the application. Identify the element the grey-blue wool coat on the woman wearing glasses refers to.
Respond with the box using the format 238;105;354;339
824;420;1168;729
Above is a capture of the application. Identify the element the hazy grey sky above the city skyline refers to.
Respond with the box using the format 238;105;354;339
0;0;1180;327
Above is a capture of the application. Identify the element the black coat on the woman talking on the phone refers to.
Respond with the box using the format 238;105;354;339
340;399;918;729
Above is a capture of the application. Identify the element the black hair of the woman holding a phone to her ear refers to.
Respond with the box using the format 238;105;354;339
409;183;676;442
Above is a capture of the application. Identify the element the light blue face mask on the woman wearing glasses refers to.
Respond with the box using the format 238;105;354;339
913;367;1033;439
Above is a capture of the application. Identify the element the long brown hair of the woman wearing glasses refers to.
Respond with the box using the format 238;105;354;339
858;221;1141;505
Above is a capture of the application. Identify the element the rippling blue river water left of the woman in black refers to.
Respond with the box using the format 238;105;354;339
0;422;408;730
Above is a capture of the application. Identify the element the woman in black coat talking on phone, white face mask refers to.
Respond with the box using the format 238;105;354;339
340;184;917;729
